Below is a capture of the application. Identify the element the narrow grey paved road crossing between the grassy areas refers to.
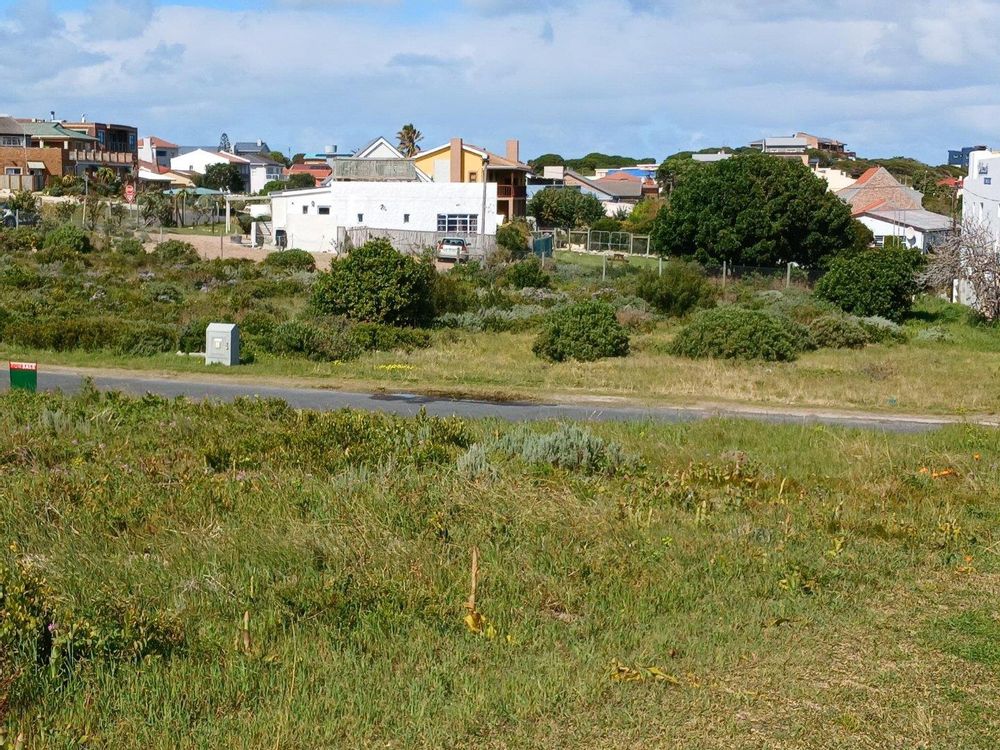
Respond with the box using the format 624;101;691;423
0;371;995;433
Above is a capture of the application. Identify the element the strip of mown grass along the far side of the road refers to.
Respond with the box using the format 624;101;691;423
7;298;1000;414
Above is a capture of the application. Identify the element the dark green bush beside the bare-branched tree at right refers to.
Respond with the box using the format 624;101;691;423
816;249;922;321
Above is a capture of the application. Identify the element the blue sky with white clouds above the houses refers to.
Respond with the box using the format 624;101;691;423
0;0;1000;164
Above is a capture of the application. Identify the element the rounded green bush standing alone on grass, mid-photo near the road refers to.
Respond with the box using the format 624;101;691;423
532;300;629;362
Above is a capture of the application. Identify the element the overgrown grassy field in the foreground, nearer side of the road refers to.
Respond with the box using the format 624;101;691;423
0;392;1000;750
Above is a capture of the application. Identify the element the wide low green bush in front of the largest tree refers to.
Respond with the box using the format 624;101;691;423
670;307;809;362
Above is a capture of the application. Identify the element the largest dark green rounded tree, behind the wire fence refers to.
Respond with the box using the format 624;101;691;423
652;152;863;266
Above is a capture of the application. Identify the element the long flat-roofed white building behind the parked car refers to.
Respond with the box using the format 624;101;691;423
271;182;499;252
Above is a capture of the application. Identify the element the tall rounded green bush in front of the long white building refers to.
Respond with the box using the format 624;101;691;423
310;239;434;325
